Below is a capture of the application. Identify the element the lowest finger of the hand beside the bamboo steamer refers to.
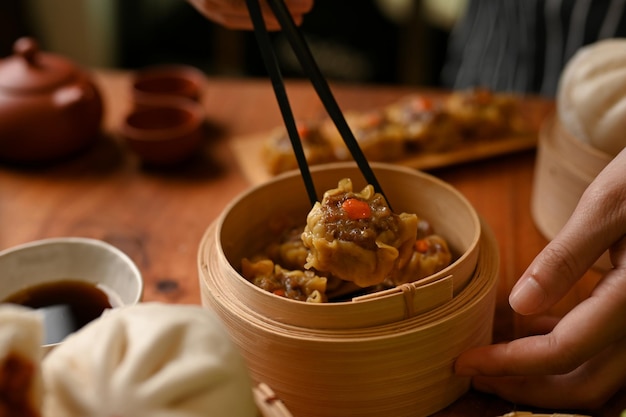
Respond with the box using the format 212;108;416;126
473;339;626;410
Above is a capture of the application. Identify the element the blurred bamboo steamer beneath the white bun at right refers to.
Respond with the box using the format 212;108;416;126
531;114;612;270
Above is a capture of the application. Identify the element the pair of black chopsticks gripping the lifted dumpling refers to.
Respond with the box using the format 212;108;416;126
246;0;389;205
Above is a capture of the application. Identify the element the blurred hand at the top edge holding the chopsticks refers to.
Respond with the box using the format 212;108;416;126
187;0;314;30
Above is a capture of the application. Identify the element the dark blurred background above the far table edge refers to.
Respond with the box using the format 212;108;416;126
0;0;448;86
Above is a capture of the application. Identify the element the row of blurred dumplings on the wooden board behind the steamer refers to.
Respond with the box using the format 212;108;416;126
262;88;533;174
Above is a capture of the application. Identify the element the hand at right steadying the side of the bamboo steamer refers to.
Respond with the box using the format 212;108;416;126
455;149;626;409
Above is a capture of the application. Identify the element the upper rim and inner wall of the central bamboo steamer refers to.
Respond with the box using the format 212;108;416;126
199;162;482;328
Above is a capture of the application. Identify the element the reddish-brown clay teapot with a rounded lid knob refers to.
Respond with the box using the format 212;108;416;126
0;38;103;162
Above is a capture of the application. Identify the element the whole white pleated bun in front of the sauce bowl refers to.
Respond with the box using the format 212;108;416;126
43;303;258;417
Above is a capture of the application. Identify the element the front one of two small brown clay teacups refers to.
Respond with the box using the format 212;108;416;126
119;97;204;166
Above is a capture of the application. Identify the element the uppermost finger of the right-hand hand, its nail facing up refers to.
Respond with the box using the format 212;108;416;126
509;150;626;315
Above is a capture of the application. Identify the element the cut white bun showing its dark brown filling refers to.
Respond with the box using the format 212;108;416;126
0;304;43;417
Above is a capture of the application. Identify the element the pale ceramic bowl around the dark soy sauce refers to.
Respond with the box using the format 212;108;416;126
0;237;143;354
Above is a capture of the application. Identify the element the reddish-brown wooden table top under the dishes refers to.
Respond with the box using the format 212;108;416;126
0;71;626;417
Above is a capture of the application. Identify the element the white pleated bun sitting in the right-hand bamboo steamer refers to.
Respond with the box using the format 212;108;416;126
557;38;626;156
